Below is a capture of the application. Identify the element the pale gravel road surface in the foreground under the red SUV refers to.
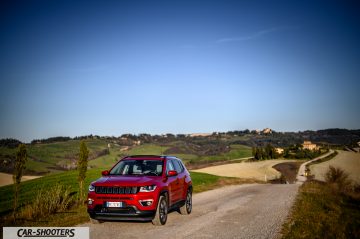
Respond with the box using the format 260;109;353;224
80;184;299;239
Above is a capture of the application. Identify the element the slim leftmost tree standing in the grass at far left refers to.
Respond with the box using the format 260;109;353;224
13;144;27;219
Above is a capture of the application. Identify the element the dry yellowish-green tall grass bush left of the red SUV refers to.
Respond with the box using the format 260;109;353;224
19;184;75;220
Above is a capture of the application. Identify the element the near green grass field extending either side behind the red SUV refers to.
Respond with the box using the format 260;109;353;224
0;169;248;226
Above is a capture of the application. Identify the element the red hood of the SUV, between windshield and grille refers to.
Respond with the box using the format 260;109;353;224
92;176;158;187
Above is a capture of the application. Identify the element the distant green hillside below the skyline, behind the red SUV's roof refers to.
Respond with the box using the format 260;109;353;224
0;138;251;175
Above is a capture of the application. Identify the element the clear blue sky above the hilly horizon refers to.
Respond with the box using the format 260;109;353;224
0;1;360;141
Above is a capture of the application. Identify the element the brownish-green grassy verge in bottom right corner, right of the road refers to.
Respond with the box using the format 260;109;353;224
282;181;360;239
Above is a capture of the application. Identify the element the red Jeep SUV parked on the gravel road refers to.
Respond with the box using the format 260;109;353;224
88;155;192;225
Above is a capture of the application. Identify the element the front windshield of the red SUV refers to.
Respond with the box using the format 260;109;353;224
110;159;163;176
